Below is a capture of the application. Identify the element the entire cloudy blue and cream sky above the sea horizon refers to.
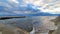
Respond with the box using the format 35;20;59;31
0;0;60;16
